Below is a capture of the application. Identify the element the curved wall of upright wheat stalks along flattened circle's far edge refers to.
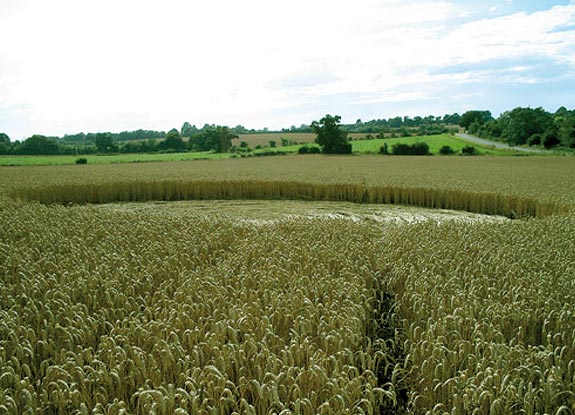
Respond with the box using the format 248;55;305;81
11;180;567;219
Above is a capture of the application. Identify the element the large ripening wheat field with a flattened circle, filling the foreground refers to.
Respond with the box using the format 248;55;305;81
0;156;575;414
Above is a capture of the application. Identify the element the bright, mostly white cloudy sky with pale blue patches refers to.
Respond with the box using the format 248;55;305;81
0;0;575;140
